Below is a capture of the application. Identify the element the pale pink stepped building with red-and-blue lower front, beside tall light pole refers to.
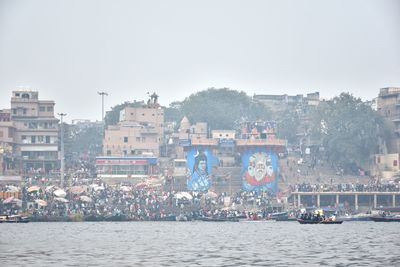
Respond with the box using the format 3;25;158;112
96;104;164;180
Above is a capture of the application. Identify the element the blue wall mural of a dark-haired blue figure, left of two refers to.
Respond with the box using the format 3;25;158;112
186;148;218;192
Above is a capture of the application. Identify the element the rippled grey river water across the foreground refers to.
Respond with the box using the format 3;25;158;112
0;222;400;267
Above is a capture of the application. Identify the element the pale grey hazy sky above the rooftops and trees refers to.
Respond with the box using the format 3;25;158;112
0;0;400;121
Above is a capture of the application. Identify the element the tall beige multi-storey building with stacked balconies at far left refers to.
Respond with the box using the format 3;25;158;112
11;91;59;174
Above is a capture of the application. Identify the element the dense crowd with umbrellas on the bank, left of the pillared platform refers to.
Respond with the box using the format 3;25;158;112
0;176;282;221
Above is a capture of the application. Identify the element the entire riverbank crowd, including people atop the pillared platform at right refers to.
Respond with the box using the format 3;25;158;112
0;177;399;222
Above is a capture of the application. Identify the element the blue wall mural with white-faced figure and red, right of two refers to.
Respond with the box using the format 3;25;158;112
242;148;279;192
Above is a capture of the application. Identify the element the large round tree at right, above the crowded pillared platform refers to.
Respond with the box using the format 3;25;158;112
312;93;388;173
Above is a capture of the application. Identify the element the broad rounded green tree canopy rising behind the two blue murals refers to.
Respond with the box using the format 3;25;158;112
179;88;271;129
